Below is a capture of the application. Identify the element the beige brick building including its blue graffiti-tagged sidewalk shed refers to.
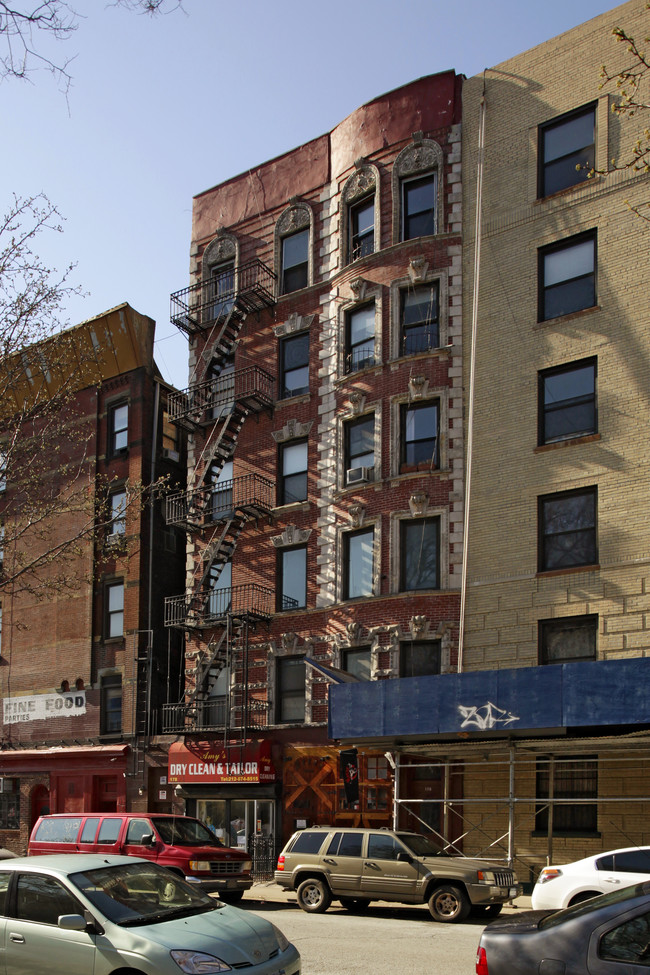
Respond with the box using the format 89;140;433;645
331;0;650;880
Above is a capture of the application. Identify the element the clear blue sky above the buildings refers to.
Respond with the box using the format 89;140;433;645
0;0;612;387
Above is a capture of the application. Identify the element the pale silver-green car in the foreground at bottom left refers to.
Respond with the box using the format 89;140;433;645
0;853;300;975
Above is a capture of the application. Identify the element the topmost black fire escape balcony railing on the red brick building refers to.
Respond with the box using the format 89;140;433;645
170;260;277;335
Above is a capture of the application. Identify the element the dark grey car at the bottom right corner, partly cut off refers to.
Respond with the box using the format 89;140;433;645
476;881;650;975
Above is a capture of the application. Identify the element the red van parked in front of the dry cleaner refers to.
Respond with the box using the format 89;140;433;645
27;813;253;904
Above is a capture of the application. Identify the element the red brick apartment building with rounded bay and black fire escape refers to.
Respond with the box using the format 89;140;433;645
163;71;463;848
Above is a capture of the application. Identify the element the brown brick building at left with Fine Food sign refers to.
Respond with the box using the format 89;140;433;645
0;304;185;852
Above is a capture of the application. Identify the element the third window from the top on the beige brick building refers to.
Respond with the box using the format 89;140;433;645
539;359;597;444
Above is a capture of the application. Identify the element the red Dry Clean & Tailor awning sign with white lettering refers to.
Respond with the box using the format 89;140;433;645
169;741;276;785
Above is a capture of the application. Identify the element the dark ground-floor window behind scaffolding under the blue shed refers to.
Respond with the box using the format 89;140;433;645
535;755;598;834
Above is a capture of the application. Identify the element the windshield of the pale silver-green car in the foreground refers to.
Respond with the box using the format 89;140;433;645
69;861;216;925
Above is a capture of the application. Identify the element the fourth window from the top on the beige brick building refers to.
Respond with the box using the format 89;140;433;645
539;488;598;572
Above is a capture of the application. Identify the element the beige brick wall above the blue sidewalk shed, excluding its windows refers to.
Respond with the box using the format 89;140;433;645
463;0;650;670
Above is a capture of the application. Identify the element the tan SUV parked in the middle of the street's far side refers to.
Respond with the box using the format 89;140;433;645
274;826;520;921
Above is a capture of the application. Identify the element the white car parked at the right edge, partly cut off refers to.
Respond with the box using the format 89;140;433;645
532;846;650;911
